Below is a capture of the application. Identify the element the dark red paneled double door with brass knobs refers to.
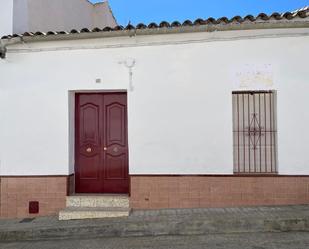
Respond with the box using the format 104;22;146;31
75;93;129;193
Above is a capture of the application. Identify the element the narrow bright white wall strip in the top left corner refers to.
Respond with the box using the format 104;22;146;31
0;0;13;37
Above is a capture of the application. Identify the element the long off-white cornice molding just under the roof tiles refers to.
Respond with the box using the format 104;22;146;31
2;28;309;53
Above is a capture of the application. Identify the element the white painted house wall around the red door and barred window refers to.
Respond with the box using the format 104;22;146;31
0;29;309;175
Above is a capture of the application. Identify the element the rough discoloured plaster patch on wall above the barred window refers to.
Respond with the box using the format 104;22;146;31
231;64;275;89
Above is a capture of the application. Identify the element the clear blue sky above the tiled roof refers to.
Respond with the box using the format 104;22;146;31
90;0;309;26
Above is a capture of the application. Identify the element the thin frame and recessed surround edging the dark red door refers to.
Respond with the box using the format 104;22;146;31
67;89;131;196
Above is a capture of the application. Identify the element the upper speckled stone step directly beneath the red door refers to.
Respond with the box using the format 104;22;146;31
66;195;129;208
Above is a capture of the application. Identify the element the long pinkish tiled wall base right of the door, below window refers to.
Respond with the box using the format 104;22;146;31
130;176;309;209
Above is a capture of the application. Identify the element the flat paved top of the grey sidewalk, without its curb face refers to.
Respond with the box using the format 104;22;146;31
0;205;309;231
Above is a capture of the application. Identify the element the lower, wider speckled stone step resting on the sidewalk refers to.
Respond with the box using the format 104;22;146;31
59;207;130;220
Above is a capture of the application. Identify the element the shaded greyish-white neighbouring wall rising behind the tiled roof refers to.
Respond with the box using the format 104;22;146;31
10;0;117;35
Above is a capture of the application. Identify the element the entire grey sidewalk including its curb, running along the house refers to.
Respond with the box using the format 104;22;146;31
0;205;309;240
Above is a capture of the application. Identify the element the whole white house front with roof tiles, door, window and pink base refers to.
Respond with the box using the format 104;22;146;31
0;7;309;217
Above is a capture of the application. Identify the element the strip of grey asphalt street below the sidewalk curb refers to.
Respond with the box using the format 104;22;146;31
0;232;309;249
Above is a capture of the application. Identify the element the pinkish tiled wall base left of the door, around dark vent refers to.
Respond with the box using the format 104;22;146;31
0;176;68;218
